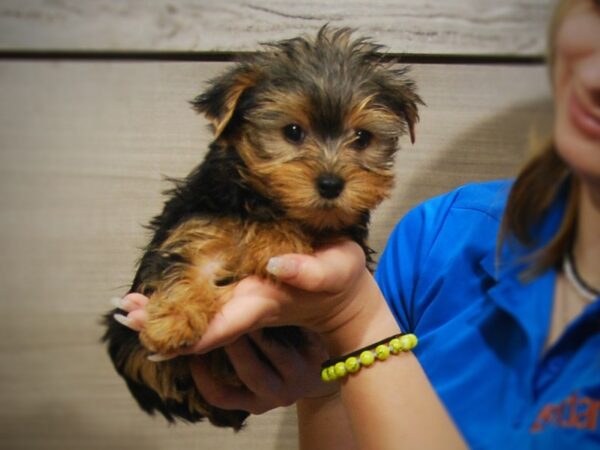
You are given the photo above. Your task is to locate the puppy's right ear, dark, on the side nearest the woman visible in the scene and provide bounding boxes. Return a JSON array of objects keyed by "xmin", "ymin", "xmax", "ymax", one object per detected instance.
[{"xmin": 377, "ymin": 69, "xmax": 425, "ymax": 144}]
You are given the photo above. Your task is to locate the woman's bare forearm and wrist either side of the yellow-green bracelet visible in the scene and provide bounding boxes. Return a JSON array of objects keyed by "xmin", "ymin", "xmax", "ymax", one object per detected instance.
[{"xmin": 325, "ymin": 272, "xmax": 466, "ymax": 450}]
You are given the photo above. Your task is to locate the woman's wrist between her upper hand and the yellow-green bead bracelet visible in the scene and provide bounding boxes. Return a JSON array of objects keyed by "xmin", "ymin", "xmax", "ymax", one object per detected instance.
[{"xmin": 322, "ymin": 270, "xmax": 401, "ymax": 357}]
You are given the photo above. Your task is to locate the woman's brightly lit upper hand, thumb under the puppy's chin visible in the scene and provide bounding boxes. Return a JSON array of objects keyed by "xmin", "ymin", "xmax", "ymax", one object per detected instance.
[{"xmin": 190, "ymin": 241, "xmax": 385, "ymax": 353}]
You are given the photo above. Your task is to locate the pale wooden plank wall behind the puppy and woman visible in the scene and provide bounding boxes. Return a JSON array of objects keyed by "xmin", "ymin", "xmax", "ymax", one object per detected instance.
[{"xmin": 0, "ymin": 0, "xmax": 553, "ymax": 450}]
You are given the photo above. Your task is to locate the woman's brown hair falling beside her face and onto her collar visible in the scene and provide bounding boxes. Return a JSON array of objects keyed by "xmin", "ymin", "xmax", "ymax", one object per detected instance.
[{"xmin": 498, "ymin": 0, "xmax": 579, "ymax": 279}]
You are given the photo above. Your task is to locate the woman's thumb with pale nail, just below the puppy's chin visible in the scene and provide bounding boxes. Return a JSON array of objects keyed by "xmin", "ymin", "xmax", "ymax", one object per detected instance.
[{"xmin": 267, "ymin": 241, "xmax": 365, "ymax": 294}]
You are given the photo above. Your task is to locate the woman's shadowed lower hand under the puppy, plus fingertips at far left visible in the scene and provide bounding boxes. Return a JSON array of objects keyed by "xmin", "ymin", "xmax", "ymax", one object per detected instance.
[{"xmin": 114, "ymin": 293, "xmax": 338, "ymax": 414}]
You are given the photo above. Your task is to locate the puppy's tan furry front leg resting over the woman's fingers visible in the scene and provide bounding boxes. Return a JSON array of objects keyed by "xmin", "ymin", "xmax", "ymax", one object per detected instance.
[{"xmin": 140, "ymin": 219, "xmax": 239, "ymax": 354}]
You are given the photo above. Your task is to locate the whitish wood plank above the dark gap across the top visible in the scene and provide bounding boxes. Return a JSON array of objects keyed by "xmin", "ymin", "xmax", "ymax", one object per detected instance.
[{"xmin": 0, "ymin": 0, "xmax": 556, "ymax": 56}]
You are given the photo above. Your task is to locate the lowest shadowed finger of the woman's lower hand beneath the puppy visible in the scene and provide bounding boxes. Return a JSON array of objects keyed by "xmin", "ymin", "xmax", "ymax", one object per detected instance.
[{"xmin": 190, "ymin": 357, "xmax": 256, "ymax": 412}]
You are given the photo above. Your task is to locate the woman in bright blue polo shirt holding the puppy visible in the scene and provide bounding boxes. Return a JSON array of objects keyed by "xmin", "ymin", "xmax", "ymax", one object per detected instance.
[{"xmin": 117, "ymin": 0, "xmax": 600, "ymax": 449}]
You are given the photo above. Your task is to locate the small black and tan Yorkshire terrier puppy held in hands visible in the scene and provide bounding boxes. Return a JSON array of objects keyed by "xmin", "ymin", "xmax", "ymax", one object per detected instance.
[{"xmin": 103, "ymin": 27, "xmax": 421, "ymax": 429}]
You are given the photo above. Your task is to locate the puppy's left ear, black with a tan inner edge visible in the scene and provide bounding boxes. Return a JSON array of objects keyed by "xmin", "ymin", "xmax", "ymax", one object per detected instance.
[{"xmin": 191, "ymin": 64, "xmax": 260, "ymax": 139}]
